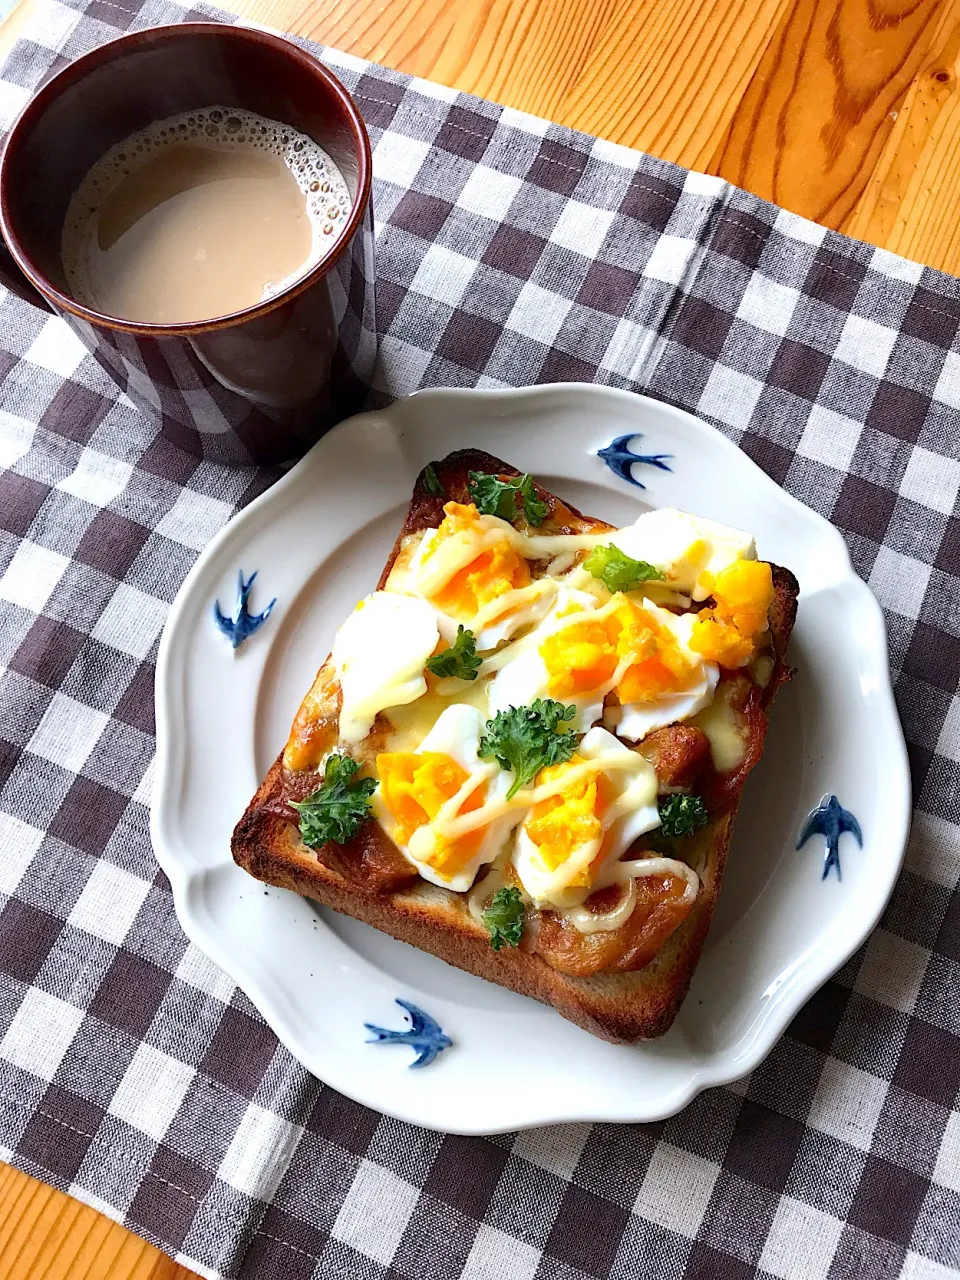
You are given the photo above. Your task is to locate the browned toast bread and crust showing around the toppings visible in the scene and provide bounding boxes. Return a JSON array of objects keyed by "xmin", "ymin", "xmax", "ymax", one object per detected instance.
[{"xmin": 232, "ymin": 449, "xmax": 797, "ymax": 1043}]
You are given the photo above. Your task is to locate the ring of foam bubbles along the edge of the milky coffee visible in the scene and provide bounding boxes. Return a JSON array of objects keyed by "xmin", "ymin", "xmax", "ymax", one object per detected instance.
[{"xmin": 61, "ymin": 106, "xmax": 352, "ymax": 306}]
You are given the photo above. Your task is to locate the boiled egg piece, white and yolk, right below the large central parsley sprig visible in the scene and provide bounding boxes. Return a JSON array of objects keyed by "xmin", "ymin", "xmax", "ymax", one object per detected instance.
[{"xmin": 512, "ymin": 727, "xmax": 660, "ymax": 910}]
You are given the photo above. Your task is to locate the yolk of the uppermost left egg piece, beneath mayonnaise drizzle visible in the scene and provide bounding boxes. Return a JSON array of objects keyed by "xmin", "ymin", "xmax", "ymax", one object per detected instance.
[{"xmin": 426, "ymin": 502, "xmax": 530, "ymax": 622}]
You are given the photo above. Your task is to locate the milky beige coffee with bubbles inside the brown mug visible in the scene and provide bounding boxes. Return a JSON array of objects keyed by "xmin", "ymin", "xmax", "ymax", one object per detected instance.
[{"xmin": 60, "ymin": 106, "xmax": 351, "ymax": 324}]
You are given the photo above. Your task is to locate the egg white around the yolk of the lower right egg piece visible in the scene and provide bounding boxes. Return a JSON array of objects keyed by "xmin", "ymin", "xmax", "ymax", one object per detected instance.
[{"xmin": 513, "ymin": 727, "xmax": 660, "ymax": 910}]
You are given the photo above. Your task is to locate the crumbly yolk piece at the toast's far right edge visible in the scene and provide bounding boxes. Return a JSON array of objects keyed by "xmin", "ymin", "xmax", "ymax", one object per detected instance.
[{"xmin": 690, "ymin": 561, "xmax": 774, "ymax": 668}]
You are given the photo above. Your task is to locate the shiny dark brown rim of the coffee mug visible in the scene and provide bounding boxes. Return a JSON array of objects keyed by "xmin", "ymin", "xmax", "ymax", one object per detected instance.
[{"xmin": 0, "ymin": 22, "xmax": 374, "ymax": 338}]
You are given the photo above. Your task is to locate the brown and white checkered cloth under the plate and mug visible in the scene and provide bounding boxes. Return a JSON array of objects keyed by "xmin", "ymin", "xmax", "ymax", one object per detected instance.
[{"xmin": 0, "ymin": 0, "xmax": 960, "ymax": 1280}]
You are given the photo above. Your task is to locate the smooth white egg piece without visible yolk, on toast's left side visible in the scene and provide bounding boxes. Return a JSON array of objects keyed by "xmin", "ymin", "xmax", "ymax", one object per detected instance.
[{"xmin": 332, "ymin": 591, "xmax": 439, "ymax": 744}]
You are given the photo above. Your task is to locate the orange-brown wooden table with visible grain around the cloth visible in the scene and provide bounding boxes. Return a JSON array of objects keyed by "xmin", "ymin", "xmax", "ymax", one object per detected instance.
[{"xmin": 0, "ymin": 0, "xmax": 960, "ymax": 1280}]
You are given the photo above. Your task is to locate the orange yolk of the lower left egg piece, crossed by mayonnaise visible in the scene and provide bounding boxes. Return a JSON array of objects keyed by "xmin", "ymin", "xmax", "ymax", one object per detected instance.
[{"xmin": 376, "ymin": 751, "xmax": 486, "ymax": 878}]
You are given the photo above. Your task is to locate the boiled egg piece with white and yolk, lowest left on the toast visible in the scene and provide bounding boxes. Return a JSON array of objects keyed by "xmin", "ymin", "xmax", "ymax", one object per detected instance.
[{"xmin": 371, "ymin": 703, "xmax": 522, "ymax": 893}]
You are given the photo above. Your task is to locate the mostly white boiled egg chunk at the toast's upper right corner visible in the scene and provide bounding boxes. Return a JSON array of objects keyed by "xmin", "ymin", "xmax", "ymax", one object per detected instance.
[{"xmin": 609, "ymin": 507, "xmax": 756, "ymax": 600}]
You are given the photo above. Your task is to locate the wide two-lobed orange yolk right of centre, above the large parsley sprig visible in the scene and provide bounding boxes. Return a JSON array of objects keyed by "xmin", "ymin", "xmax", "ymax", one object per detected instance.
[{"xmin": 540, "ymin": 595, "xmax": 696, "ymax": 703}]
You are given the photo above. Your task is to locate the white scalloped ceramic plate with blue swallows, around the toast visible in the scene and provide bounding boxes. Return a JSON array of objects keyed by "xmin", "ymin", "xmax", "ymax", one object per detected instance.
[{"xmin": 152, "ymin": 384, "xmax": 910, "ymax": 1133}]
